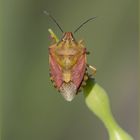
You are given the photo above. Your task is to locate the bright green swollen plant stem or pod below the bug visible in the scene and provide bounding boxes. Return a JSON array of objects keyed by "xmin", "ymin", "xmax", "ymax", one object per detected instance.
[{"xmin": 84, "ymin": 79, "xmax": 133, "ymax": 140}]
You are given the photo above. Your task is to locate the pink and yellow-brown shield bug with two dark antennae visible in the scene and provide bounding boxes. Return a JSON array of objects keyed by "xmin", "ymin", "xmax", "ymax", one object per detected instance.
[{"xmin": 44, "ymin": 11, "xmax": 96, "ymax": 101}]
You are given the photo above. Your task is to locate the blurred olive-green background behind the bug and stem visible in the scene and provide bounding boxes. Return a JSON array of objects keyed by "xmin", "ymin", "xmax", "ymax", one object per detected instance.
[{"xmin": 0, "ymin": 0, "xmax": 140, "ymax": 140}]
